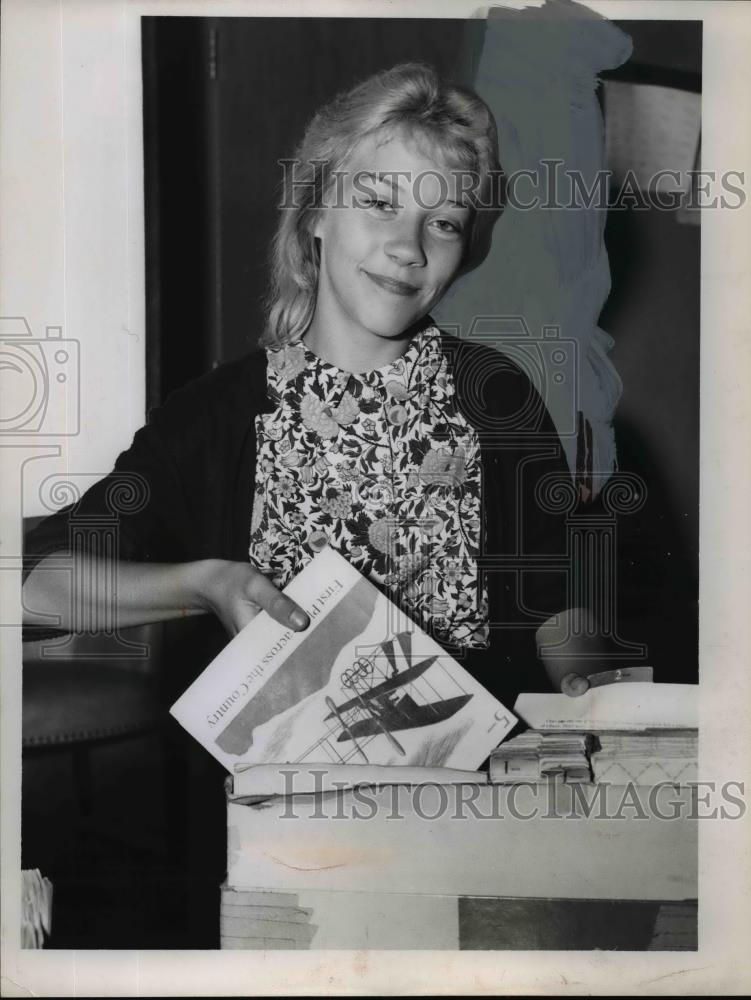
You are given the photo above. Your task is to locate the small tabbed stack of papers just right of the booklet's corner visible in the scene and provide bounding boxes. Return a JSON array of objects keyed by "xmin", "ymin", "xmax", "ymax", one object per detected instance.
[{"xmin": 490, "ymin": 731, "xmax": 592, "ymax": 784}]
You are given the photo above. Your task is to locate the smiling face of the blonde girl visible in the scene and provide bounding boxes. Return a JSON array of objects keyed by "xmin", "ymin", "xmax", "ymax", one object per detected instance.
[{"xmin": 312, "ymin": 136, "xmax": 470, "ymax": 360}]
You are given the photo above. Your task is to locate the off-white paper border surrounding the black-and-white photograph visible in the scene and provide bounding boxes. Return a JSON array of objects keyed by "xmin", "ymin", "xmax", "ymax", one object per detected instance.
[{"xmin": 0, "ymin": 0, "xmax": 751, "ymax": 996}]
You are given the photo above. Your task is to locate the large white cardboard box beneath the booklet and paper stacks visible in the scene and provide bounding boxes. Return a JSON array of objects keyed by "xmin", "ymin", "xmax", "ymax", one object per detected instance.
[{"xmin": 223, "ymin": 783, "xmax": 698, "ymax": 948}]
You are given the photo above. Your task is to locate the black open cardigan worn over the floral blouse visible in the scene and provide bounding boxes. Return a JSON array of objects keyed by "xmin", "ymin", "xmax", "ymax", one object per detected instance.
[{"xmin": 24, "ymin": 334, "xmax": 569, "ymax": 698}]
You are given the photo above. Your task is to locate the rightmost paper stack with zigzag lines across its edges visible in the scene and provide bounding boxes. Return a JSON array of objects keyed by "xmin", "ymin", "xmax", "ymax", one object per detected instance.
[{"xmin": 592, "ymin": 729, "xmax": 698, "ymax": 785}]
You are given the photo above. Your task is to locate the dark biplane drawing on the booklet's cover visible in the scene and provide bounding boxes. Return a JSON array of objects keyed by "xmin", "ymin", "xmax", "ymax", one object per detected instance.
[{"xmin": 296, "ymin": 631, "xmax": 472, "ymax": 763}]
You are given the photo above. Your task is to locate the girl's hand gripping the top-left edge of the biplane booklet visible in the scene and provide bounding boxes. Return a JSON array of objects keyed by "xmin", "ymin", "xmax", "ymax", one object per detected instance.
[{"xmin": 194, "ymin": 559, "xmax": 310, "ymax": 636}]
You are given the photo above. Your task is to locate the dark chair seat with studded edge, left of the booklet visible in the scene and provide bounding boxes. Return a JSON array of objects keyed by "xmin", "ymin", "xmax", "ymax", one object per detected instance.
[{"xmin": 23, "ymin": 660, "xmax": 163, "ymax": 748}]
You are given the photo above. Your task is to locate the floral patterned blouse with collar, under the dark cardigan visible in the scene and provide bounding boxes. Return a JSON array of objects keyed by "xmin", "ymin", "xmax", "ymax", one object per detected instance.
[{"xmin": 249, "ymin": 326, "xmax": 488, "ymax": 647}]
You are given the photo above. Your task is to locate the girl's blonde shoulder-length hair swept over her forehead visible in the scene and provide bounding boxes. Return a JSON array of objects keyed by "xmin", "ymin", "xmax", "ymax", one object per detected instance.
[{"xmin": 261, "ymin": 63, "xmax": 501, "ymax": 347}]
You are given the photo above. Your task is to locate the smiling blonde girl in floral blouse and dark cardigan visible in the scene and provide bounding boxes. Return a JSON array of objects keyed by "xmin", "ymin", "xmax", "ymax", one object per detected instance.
[{"xmin": 24, "ymin": 64, "xmax": 582, "ymax": 698}]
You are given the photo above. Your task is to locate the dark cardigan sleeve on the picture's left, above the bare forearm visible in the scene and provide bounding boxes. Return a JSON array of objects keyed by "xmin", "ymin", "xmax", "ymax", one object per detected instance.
[{"xmin": 23, "ymin": 351, "xmax": 267, "ymax": 639}]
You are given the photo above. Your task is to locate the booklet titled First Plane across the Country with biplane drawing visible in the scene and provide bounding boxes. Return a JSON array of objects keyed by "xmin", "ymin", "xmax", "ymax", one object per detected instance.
[{"xmin": 170, "ymin": 548, "xmax": 517, "ymax": 772}]
